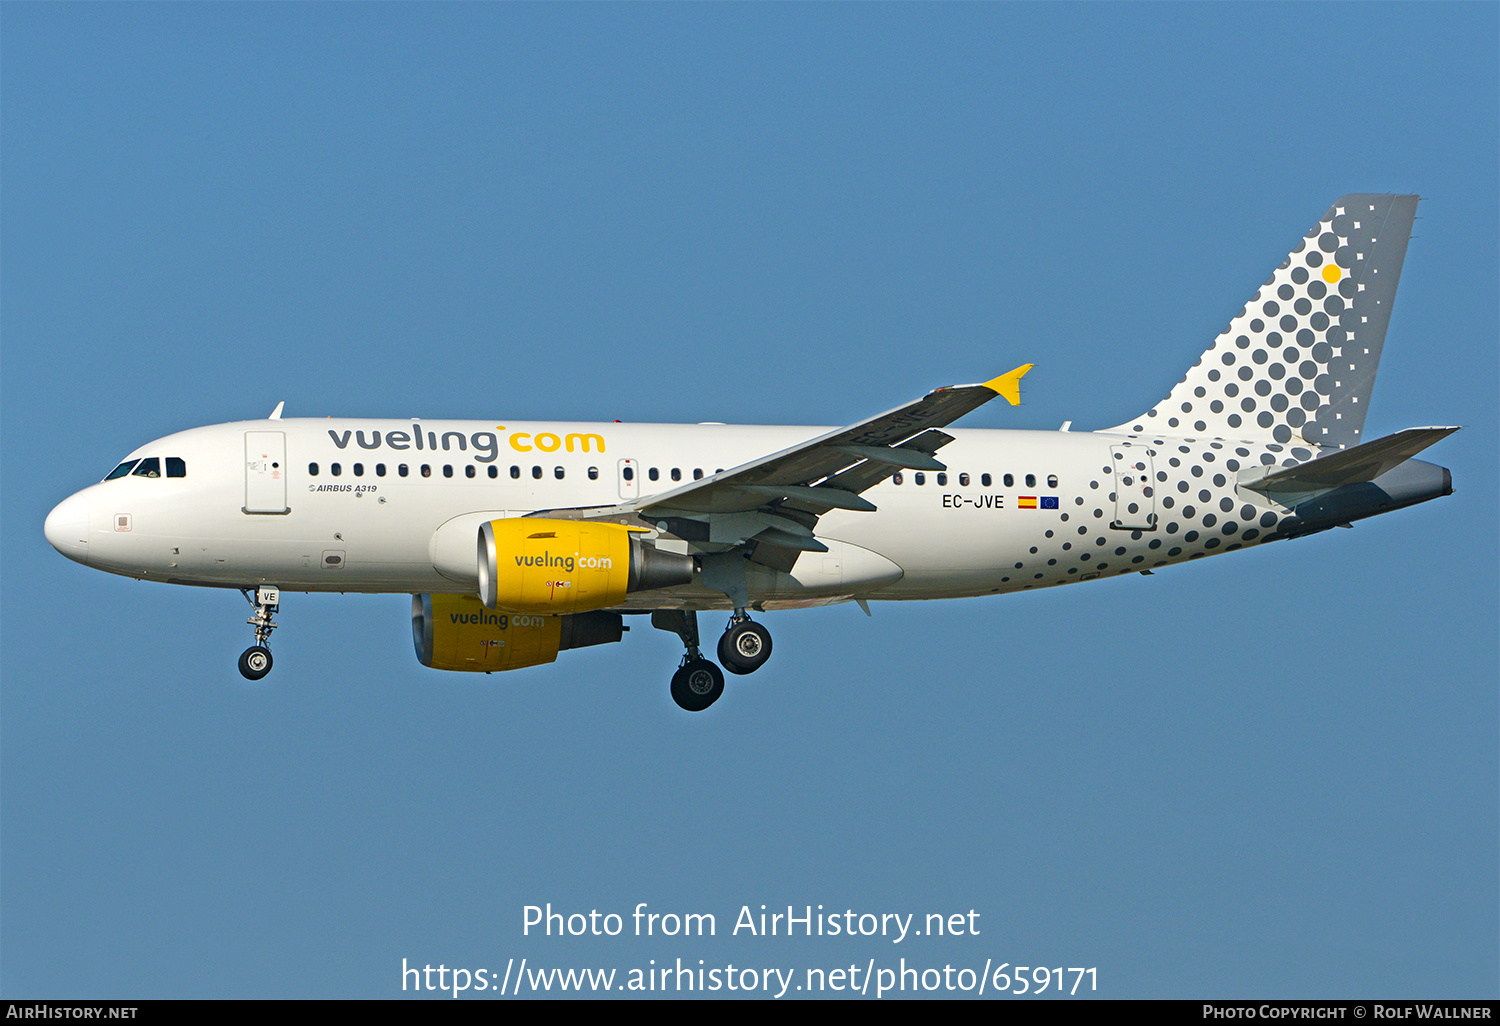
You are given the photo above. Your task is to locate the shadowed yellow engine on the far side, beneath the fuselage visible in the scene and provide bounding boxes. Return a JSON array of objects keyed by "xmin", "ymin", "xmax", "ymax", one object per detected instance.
[{"xmin": 411, "ymin": 596, "xmax": 626, "ymax": 674}]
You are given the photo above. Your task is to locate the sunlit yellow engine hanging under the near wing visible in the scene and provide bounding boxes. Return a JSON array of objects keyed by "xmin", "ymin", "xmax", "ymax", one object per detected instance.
[{"xmin": 479, "ymin": 516, "xmax": 693, "ymax": 615}]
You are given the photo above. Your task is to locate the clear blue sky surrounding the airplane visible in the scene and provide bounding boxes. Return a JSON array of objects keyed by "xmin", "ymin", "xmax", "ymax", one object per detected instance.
[{"xmin": 0, "ymin": 5, "xmax": 1500, "ymax": 998}]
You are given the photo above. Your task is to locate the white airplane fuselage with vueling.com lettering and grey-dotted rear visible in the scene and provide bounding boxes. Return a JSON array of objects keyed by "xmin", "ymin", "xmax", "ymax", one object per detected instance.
[{"xmin": 48, "ymin": 419, "xmax": 1314, "ymax": 609}]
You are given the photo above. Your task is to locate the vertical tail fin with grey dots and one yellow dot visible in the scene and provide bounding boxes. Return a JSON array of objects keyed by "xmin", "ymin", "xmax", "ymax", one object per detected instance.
[{"xmin": 1110, "ymin": 194, "xmax": 1418, "ymax": 449}]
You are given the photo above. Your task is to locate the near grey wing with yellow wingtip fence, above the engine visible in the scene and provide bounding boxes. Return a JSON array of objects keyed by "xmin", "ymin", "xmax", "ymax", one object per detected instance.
[{"xmin": 534, "ymin": 363, "xmax": 1032, "ymax": 569}]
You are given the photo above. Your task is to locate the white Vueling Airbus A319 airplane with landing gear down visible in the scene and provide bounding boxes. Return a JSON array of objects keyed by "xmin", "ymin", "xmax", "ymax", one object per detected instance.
[{"xmin": 44, "ymin": 194, "xmax": 1458, "ymax": 711}]
